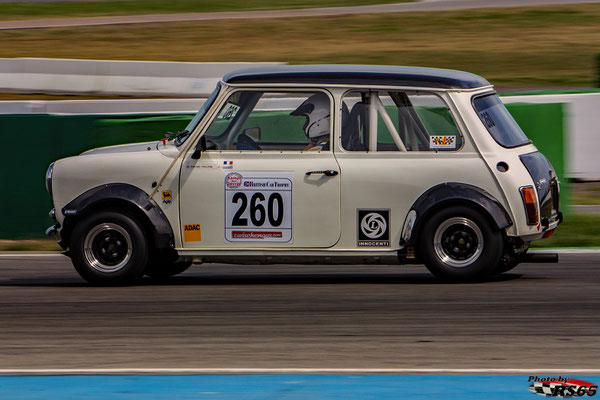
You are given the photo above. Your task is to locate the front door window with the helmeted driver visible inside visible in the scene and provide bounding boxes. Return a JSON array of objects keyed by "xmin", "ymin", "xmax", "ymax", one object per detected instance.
[{"xmin": 205, "ymin": 91, "xmax": 331, "ymax": 151}]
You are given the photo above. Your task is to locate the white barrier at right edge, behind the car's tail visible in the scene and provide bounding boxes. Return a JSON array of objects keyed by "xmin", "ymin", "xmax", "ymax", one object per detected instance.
[{"xmin": 502, "ymin": 93, "xmax": 600, "ymax": 180}]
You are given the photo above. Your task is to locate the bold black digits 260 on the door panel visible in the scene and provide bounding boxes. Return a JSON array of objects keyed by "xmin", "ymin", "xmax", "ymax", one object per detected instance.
[{"xmin": 231, "ymin": 192, "xmax": 283, "ymax": 227}]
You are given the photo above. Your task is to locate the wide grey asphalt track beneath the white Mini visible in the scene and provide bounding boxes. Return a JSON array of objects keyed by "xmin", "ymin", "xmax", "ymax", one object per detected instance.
[{"xmin": 0, "ymin": 253, "xmax": 600, "ymax": 370}]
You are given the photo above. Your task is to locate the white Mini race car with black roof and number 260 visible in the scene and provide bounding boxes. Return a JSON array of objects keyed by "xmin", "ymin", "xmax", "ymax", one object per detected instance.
[{"xmin": 46, "ymin": 65, "xmax": 562, "ymax": 284}]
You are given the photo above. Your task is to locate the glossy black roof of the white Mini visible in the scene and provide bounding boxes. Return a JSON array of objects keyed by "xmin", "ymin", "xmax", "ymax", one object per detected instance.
[{"xmin": 223, "ymin": 65, "xmax": 490, "ymax": 89}]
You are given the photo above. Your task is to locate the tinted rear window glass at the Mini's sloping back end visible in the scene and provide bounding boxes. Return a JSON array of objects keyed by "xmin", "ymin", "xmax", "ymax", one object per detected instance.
[{"xmin": 473, "ymin": 94, "xmax": 531, "ymax": 147}]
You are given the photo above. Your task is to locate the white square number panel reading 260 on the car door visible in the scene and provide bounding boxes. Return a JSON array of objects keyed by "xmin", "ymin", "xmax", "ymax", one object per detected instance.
[{"xmin": 224, "ymin": 172, "xmax": 294, "ymax": 243}]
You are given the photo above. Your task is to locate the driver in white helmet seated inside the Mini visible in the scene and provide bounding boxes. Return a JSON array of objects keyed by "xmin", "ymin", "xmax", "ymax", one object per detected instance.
[{"xmin": 290, "ymin": 93, "xmax": 330, "ymax": 151}]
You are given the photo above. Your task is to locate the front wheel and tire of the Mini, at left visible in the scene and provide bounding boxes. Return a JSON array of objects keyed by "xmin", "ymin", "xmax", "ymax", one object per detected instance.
[{"xmin": 70, "ymin": 211, "xmax": 149, "ymax": 286}]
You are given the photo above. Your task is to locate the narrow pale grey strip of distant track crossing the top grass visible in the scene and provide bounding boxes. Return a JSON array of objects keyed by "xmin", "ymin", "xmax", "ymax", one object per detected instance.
[{"xmin": 0, "ymin": 0, "xmax": 600, "ymax": 30}]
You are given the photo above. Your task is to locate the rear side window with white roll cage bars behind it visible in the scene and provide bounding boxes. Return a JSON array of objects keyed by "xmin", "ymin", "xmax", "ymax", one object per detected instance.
[{"xmin": 342, "ymin": 91, "xmax": 462, "ymax": 151}]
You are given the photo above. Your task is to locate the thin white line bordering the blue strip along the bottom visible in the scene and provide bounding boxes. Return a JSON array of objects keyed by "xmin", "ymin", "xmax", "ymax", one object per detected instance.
[{"xmin": 0, "ymin": 368, "xmax": 600, "ymax": 375}]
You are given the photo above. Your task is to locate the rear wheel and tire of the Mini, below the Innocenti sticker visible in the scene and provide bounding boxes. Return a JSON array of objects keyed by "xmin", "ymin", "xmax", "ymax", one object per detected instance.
[{"xmin": 418, "ymin": 206, "xmax": 504, "ymax": 280}]
